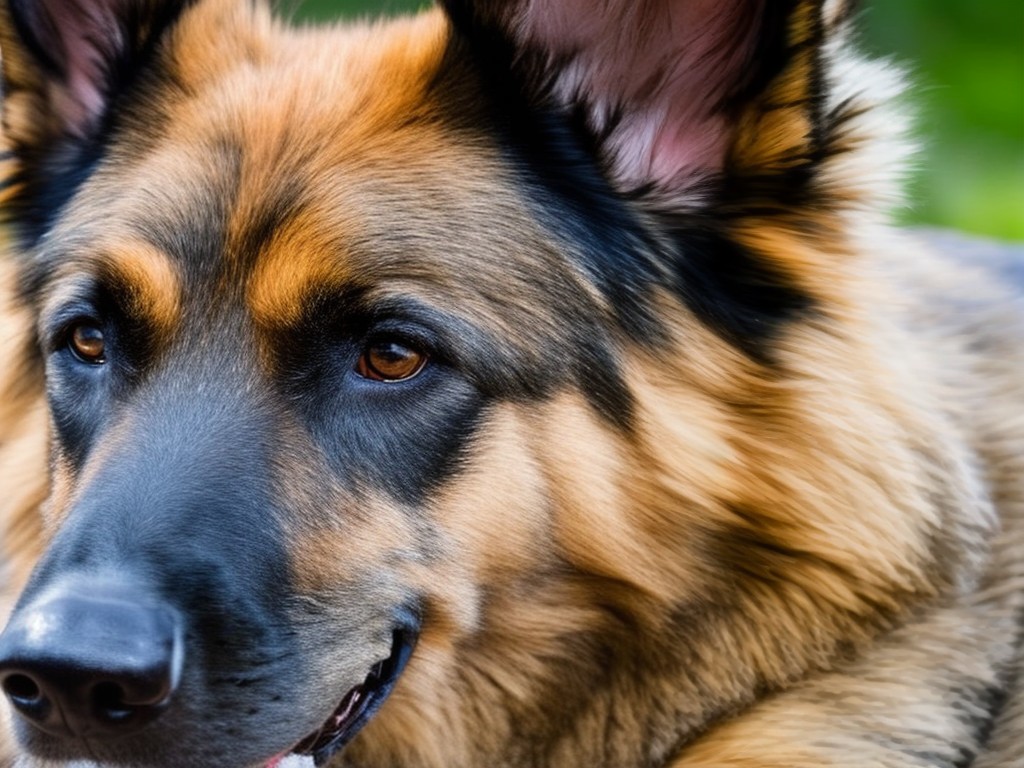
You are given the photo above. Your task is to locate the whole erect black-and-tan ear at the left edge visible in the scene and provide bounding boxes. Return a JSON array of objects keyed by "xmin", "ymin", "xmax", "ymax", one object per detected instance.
[{"xmin": 0, "ymin": 0, "xmax": 190, "ymax": 240}]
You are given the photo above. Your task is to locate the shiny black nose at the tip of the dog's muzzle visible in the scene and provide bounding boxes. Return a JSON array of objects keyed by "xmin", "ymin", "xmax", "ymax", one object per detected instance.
[{"xmin": 0, "ymin": 585, "xmax": 183, "ymax": 737}]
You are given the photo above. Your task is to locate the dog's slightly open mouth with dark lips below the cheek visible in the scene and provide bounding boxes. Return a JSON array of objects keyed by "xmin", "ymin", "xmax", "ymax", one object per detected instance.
[{"xmin": 266, "ymin": 629, "xmax": 418, "ymax": 768}]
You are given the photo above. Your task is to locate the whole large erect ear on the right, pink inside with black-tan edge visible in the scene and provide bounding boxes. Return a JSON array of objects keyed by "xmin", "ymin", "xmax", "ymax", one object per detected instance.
[{"xmin": 444, "ymin": 0, "xmax": 851, "ymax": 197}]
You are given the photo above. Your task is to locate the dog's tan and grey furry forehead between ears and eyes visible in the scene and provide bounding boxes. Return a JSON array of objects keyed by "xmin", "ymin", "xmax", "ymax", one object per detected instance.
[{"xmin": 49, "ymin": 7, "xmax": 579, "ymax": 335}]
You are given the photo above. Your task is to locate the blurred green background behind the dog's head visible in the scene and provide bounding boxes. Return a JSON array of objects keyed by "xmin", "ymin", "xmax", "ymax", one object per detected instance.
[{"xmin": 286, "ymin": 0, "xmax": 1024, "ymax": 240}]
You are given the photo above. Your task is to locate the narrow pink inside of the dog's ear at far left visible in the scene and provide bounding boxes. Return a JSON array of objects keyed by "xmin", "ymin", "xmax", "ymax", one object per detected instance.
[{"xmin": 40, "ymin": 0, "xmax": 126, "ymax": 136}]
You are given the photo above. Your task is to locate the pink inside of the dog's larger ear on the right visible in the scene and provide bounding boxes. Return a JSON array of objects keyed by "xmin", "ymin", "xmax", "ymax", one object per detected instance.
[{"xmin": 515, "ymin": 0, "xmax": 765, "ymax": 188}]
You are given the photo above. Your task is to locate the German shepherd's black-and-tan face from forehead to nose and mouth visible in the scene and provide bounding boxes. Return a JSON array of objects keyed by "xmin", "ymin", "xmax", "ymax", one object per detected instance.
[{"xmin": 5, "ymin": 3, "xmax": 655, "ymax": 766}]
